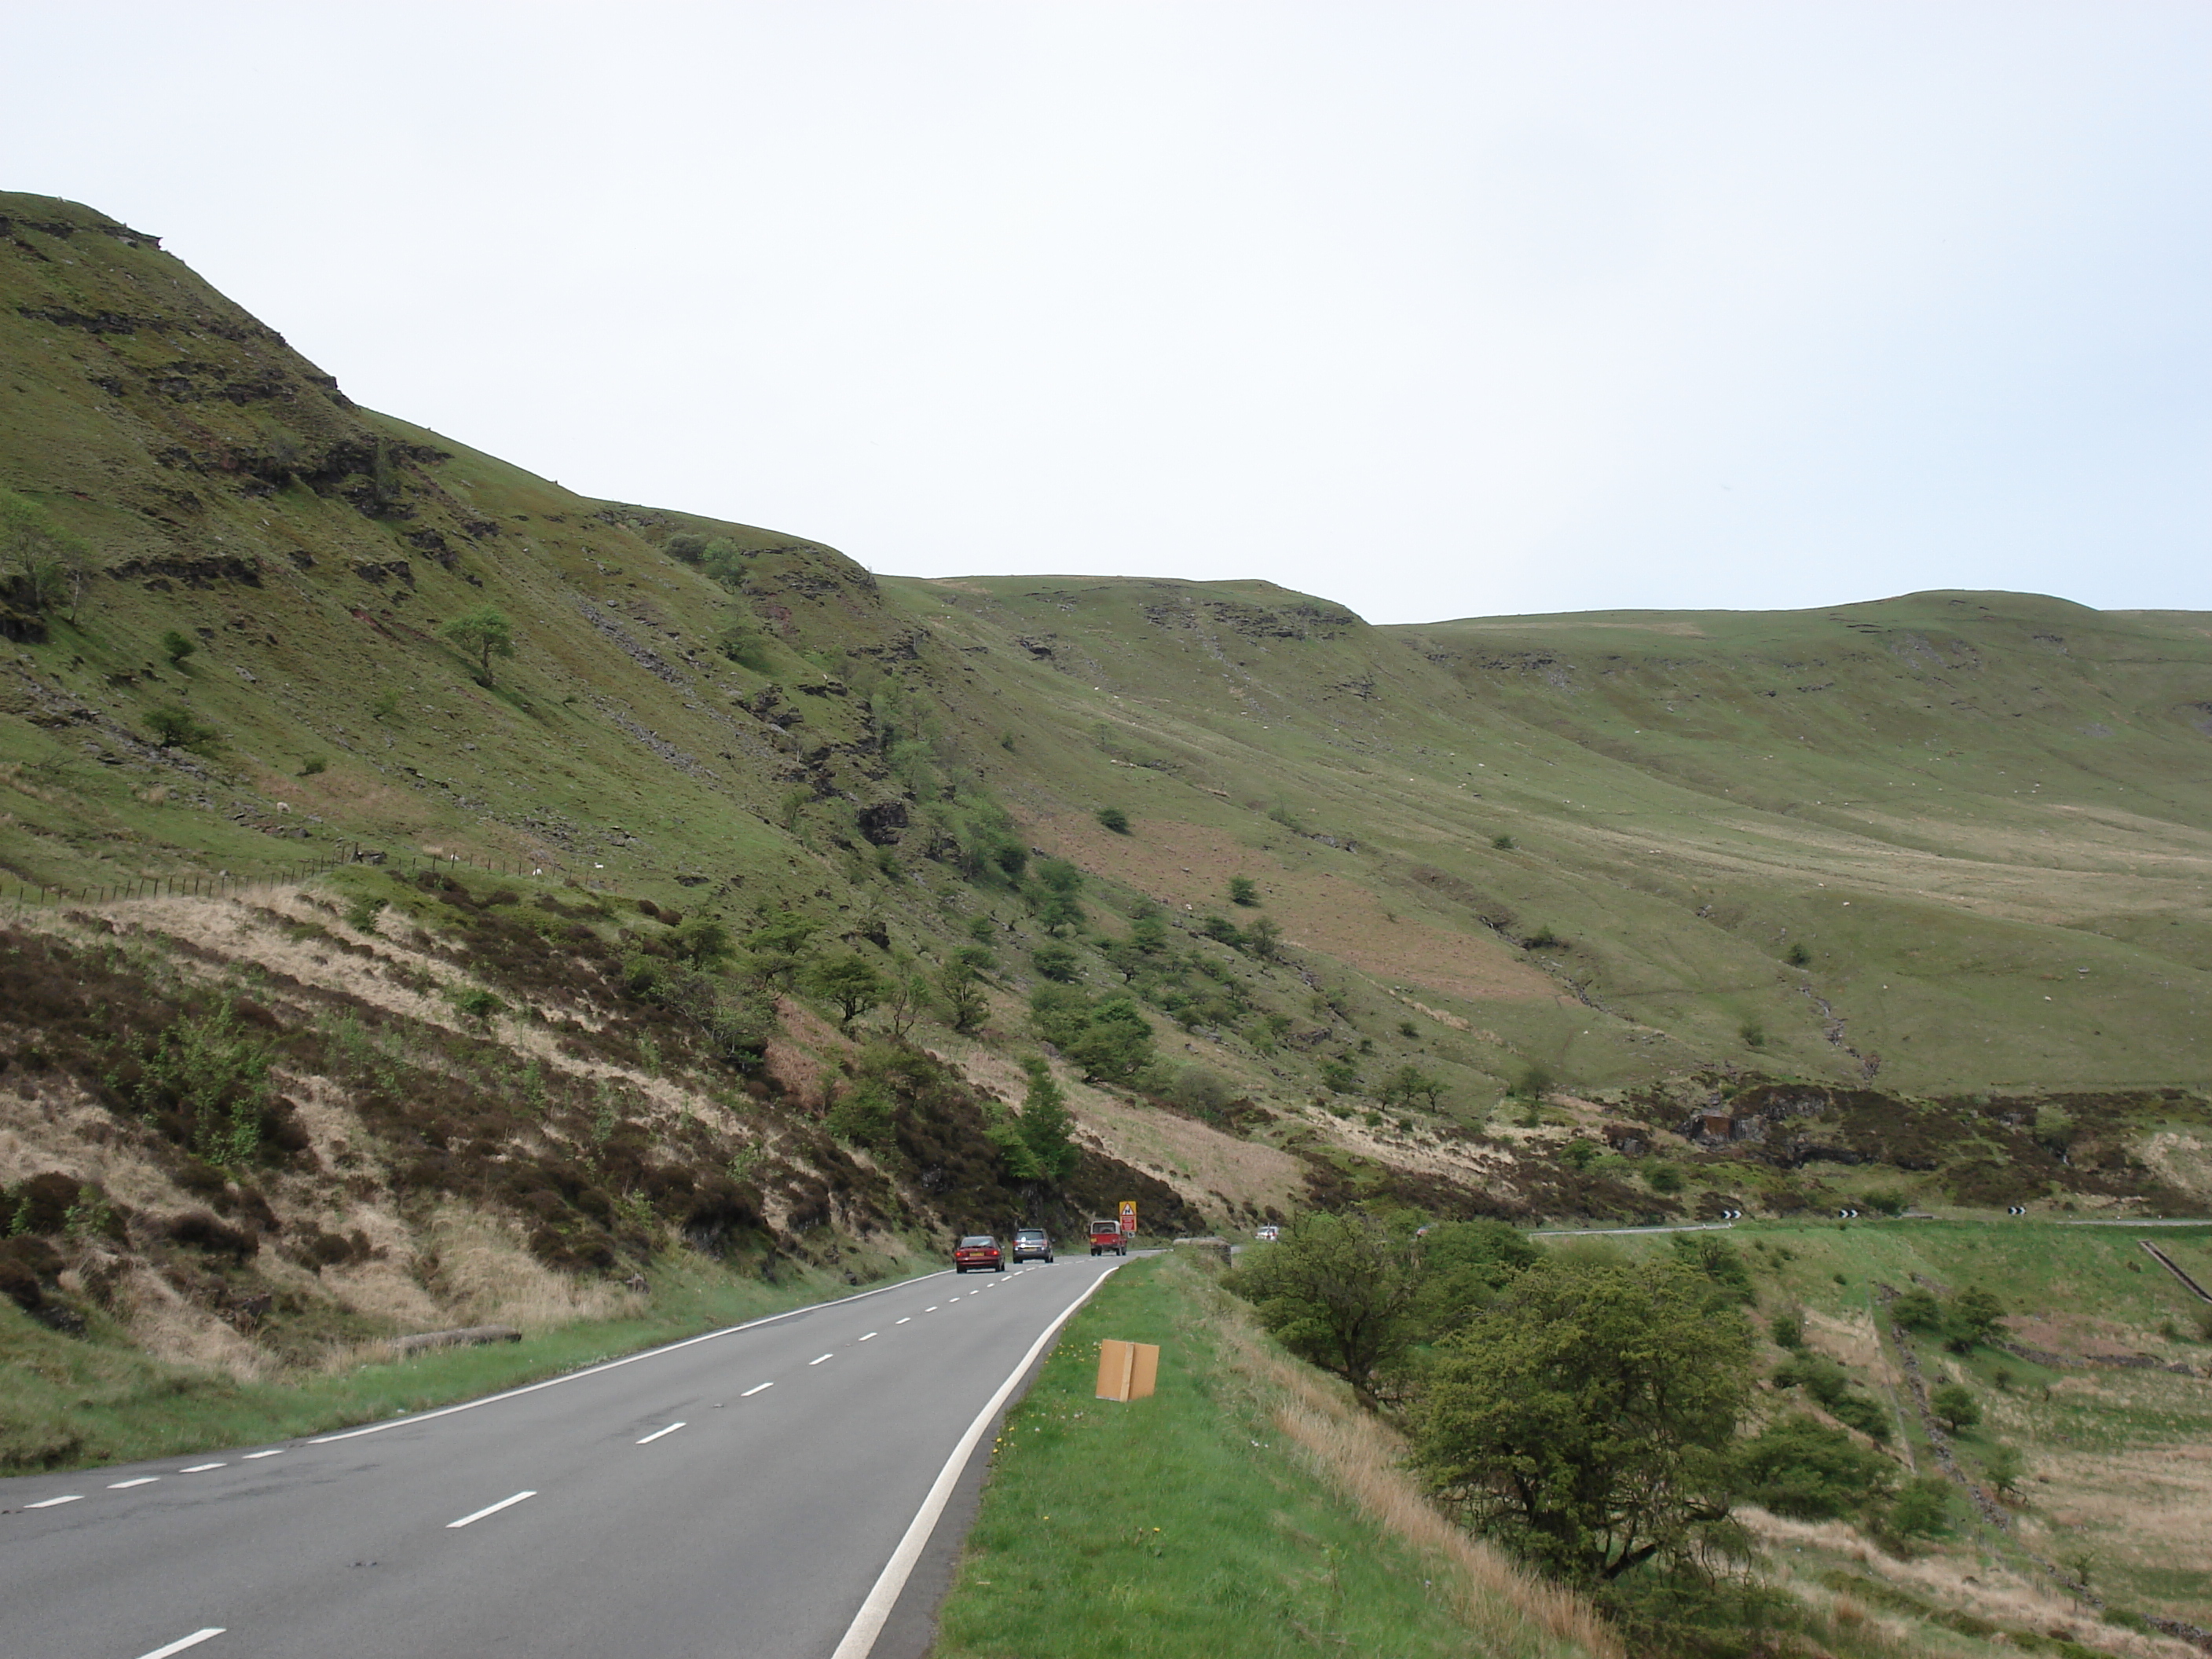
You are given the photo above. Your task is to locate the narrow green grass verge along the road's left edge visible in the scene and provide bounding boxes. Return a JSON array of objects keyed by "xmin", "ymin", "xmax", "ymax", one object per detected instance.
[{"xmin": 0, "ymin": 1261, "xmax": 936, "ymax": 1475}]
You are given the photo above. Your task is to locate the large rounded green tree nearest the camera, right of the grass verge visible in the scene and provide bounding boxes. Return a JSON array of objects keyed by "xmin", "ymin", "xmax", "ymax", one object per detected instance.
[{"xmin": 1409, "ymin": 1256, "xmax": 1752, "ymax": 1584}]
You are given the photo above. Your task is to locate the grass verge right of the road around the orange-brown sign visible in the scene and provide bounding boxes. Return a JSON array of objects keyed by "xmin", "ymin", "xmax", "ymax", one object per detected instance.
[{"xmin": 936, "ymin": 1256, "xmax": 1619, "ymax": 1659}]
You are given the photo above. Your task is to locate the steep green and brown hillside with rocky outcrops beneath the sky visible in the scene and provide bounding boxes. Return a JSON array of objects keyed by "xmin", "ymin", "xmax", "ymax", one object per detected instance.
[{"xmin": 0, "ymin": 197, "xmax": 2212, "ymax": 1415}]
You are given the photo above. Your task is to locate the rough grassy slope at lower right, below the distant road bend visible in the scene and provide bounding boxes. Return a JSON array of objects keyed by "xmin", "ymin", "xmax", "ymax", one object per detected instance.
[{"xmin": 1619, "ymin": 1219, "xmax": 2212, "ymax": 1641}]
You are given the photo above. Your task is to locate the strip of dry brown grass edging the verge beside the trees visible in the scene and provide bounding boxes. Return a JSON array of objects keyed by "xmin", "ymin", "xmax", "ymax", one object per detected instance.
[{"xmin": 1214, "ymin": 1292, "xmax": 1626, "ymax": 1659}]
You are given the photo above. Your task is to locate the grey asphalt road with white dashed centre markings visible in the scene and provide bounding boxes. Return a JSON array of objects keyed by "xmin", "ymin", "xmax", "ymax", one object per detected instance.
[{"xmin": 0, "ymin": 1256, "xmax": 1119, "ymax": 1659}]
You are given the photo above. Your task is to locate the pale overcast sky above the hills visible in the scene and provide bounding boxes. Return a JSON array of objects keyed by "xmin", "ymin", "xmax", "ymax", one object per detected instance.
[{"xmin": 0, "ymin": 0, "xmax": 2212, "ymax": 621}]
